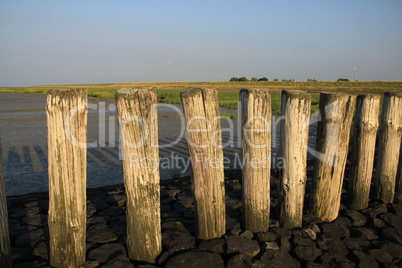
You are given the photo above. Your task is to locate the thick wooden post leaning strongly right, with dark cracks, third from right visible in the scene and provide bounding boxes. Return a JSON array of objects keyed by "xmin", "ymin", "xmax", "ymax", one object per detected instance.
[{"xmin": 312, "ymin": 93, "xmax": 356, "ymax": 222}]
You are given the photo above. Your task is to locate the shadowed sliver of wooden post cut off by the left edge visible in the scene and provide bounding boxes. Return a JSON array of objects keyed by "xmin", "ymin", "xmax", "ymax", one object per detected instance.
[{"xmin": 0, "ymin": 142, "xmax": 12, "ymax": 268}]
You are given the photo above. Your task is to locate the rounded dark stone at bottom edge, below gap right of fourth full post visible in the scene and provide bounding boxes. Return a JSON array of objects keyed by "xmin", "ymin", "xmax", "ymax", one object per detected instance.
[{"xmin": 260, "ymin": 250, "xmax": 301, "ymax": 268}]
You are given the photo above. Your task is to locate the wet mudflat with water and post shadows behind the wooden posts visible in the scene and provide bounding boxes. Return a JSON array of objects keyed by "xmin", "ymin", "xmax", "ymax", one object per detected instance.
[{"xmin": 0, "ymin": 93, "xmax": 240, "ymax": 195}]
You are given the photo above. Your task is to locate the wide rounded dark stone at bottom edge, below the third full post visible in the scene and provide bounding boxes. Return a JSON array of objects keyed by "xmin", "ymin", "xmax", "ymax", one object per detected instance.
[{"xmin": 165, "ymin": 251, "xmax": 225, "ymax": 268}]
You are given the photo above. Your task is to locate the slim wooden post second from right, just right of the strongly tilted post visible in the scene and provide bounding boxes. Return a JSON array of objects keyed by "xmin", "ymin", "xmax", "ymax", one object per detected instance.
[{"xmin": 348, "ymin": 95, "xmax": 380, "ymax": 210}]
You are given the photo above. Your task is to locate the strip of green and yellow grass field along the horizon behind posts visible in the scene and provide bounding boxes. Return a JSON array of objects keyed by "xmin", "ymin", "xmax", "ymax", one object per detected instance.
[{"xmin": 0, "ymin": 81, "xmax": 402, "ymax": 114}]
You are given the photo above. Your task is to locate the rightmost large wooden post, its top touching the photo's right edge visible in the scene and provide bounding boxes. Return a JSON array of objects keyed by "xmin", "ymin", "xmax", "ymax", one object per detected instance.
[{"xmin": 374, "ymin": 93, "xmax": 402, "ymax": 203}]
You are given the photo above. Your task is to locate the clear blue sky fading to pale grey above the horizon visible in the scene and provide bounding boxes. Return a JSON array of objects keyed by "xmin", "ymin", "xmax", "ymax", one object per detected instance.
[{"xmin": 0, "ymin": 0, "xmax": 402, "ymax": 86}]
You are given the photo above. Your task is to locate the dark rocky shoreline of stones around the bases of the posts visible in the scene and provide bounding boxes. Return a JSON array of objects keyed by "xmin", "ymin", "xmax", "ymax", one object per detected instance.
[{"xmin": 7, "ymin": 170, "xmax": 402, "ymax": 268}]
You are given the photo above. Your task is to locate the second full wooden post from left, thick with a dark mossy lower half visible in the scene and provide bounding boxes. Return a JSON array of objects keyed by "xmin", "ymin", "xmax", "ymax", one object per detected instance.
[{"xmin": 116, "ymin": 88, "xmax": 162, "ymax": 263}]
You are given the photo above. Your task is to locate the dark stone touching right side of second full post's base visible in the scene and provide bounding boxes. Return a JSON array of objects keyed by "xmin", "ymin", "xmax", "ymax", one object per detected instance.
[{"xmin": 162, "ymin": 229, "xmax": 196, "ymax": 254}]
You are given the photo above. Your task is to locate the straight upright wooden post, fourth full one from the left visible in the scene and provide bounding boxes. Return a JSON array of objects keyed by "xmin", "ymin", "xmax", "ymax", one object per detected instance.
[{"xmin": 240, "ymin": 89, "xmax": 271, "ymax": 233}]
